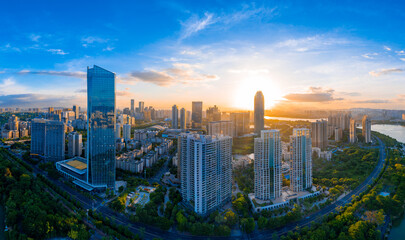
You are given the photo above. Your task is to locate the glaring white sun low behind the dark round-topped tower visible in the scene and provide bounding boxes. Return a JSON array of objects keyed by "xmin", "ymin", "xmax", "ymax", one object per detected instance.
[{"xmin": 233, "ymin": 76, "xmax": 283, "ymax": 110}]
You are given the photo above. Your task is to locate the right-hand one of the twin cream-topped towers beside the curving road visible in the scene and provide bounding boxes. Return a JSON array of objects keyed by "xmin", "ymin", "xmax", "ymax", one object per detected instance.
[{"xmin": 290, "ymin": 128, "xmax": 312, "ymax": 192}]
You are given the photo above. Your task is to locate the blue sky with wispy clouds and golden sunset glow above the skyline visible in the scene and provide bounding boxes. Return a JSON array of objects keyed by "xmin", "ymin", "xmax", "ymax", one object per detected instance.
[{"xmin": 0, "ymin": 0, "xmax": 405, "ymax": 110}]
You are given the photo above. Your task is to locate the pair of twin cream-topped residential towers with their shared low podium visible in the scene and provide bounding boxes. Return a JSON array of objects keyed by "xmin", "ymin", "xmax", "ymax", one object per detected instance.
[{"xmin": 249, "ymin": 128, "xmax": 312, "ymax": 209}]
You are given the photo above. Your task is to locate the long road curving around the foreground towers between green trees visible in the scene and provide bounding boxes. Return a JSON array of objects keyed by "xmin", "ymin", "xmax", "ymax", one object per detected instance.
[{"xmin": 6, "ymin": 138, "xmax": 386, "ymax": 240}]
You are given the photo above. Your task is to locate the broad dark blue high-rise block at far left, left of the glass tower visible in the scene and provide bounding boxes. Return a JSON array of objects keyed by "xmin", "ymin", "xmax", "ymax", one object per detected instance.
[{"xmin": 31, "ymin": 119, "xmax": 65, "ymax": 161}]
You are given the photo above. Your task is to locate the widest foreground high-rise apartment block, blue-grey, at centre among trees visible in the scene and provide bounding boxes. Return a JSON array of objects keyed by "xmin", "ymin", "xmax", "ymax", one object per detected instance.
[{"xmin": 178, "ymin": 133, "xmax": 232, "ymax": 215}]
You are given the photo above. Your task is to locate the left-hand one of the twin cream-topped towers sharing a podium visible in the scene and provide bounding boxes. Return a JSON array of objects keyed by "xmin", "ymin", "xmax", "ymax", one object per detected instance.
[{"xmin": 254, "ymin": 130, "xmax": 282, "ymax": 200}]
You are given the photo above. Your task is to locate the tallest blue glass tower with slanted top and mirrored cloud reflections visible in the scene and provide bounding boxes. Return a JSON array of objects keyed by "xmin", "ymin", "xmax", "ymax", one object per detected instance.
[{"xmin": 87, "ymin": 65, "xmax": 116, "ymax": 188}]
